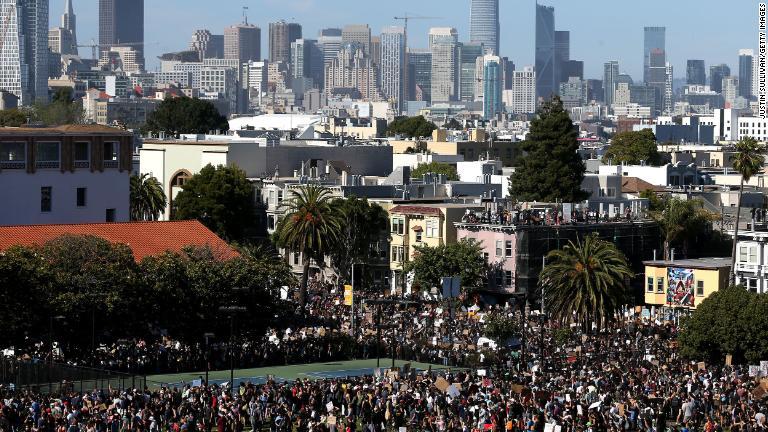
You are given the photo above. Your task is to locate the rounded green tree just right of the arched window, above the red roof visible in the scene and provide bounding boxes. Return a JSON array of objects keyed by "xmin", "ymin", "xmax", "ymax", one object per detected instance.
[{"xmin": 171, "ymin": 164, "xmax": 254, "ymax": 241}]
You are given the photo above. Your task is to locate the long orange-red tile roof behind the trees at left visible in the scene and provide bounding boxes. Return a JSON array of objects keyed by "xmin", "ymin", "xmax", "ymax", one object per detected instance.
[{"xmin": 0, "ymin": 221, "xmax": 239, "ymax": 262}]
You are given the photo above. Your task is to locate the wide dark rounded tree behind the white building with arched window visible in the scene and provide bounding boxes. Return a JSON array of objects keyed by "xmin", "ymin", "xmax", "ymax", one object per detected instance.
[{"xmin": 144, "ymin": 97, "xmax": 229, "ymax": 136}]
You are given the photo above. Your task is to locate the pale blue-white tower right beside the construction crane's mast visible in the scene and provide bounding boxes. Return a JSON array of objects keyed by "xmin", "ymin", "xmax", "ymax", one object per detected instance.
[{"xmin": 377, "ymin": 27, "xmax": 406, "ymax": 113}]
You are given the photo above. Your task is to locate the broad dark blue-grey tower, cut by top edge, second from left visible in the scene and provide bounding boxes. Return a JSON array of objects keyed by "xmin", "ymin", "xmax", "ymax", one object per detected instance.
[{"xmin": 99, "ymin": 0, "xmax": 144, "ymax": 66}]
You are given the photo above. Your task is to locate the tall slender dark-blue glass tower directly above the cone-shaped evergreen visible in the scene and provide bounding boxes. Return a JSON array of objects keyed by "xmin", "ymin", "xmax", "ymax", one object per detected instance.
[{"xmin": 536, "ymin": 4, "xmax": 557, "ymax": 99}]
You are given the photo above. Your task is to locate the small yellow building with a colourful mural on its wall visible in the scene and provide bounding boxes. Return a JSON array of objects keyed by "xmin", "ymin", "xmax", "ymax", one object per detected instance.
[{"xmin": 643, "ymin": 258, "xmax": 731, "ymax": 309}]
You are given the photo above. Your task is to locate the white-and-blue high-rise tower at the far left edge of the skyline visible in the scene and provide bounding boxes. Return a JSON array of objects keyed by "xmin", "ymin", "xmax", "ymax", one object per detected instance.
[{"xmin": 0, "ymin": 0, "xmax": 49, "ymax": 105}]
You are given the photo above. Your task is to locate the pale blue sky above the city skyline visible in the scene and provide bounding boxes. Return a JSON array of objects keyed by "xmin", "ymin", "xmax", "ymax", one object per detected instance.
[{"xmin": 50, "ymin": 0, "xmax": 758, "ymax": 79}]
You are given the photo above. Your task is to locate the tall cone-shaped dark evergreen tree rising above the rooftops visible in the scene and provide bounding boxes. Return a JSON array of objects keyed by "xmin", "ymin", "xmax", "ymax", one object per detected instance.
[{"xmin": 509, "ymin": 96, "xmax": 588, "ymax": 202}]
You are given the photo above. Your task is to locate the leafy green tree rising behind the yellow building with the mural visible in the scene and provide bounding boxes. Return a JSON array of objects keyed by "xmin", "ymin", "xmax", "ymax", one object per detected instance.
[{"xmin": 650, "ymin": 198, "xmax": 718, "ymax": 259}]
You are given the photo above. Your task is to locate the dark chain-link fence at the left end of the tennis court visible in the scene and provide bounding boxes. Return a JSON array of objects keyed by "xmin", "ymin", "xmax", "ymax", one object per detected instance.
[{"xmin": 0, "ymin": 357, "xmax": 147, "ymax": 393}]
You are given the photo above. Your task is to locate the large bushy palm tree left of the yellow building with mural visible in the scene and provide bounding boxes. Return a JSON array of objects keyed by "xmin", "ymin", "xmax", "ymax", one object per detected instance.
[{"xmin": 539, "ymin": 234, "xmax": 632, "ymax": 332}]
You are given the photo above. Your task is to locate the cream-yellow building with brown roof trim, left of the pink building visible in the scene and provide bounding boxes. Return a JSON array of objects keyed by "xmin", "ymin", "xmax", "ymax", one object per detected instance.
[{"xmin": 387, "ymin": 203, "xmax": 482, "ymax": 290}]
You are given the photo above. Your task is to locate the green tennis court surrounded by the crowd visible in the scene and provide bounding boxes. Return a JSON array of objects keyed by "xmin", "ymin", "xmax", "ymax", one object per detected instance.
[{"xmin": 147, "ymin": 359, "xmax": 445, "ymax": 387}]
